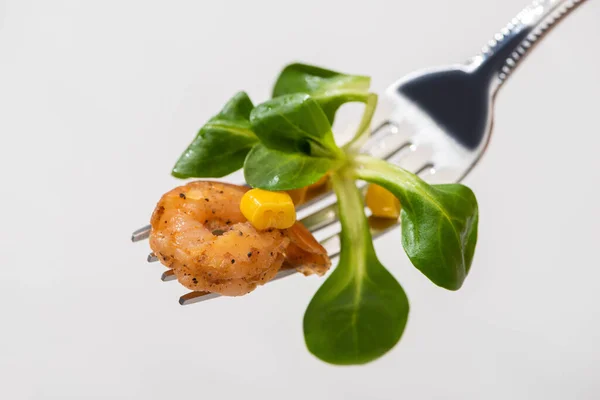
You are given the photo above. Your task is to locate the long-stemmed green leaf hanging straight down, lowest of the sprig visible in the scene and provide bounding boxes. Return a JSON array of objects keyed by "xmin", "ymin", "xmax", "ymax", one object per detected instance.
[{"xmin": 304, "ymin": 170, "xmax": 409, "ymax": 365}]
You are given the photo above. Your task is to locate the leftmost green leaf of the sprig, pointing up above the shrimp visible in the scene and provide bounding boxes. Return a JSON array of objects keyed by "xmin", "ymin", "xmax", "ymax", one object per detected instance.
[{"xmin": 172, "ymin": 92, "xmax": 258, "ymax": 178}]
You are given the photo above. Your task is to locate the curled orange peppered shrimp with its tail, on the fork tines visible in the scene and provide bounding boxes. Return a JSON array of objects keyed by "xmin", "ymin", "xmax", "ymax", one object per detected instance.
[{"xmin": 150, "ymin": 181, "xmax": 329, "ymax": 296}]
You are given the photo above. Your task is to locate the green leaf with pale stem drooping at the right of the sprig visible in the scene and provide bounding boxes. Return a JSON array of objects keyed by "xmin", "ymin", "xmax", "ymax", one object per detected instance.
[{"xmin": 356, "ymin": 156, "xmax": 479, "ymax": 290}]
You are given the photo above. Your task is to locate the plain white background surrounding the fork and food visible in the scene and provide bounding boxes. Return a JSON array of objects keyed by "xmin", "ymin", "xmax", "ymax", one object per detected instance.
[{"xmin": 0, "ymin": 0, "xmax": 600, "ymax": 400}]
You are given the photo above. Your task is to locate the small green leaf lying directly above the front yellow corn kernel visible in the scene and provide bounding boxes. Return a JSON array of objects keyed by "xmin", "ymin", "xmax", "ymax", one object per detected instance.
[{"xmin": 244, "ymin": 144, "xmax": 339, "ymax": 190}]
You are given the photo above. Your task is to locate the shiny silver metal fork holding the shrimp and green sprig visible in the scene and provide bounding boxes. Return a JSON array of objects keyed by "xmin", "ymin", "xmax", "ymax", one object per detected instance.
[{"xmin": 131, "ymin": 0, "xmax": 586, "ymax": 305}]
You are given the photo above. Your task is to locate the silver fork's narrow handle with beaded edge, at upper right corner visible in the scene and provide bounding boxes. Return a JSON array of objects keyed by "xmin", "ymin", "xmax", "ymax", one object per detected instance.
[{"xmin": 473, "ymin": 0, "xmax": 586, "ymax": 92}]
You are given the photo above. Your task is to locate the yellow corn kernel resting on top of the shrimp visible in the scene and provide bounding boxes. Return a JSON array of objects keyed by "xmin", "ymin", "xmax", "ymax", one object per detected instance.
[{"xmin": 240, "ymin": 189, "xmax": 296, "ymax": 230}]
